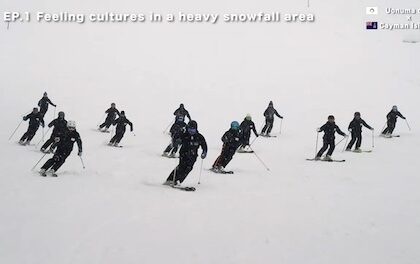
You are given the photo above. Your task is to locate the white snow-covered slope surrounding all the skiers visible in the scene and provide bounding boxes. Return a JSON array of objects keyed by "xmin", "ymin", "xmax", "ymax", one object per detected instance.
[{"xmin": 0, "ymin": 0, "xmax": 420, "ymax": 264}]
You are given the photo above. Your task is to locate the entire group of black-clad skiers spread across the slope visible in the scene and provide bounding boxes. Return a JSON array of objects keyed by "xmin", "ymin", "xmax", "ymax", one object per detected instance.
[{"xmin": 14, "ymin": 93, "xmax": 405, "ymax": 182}]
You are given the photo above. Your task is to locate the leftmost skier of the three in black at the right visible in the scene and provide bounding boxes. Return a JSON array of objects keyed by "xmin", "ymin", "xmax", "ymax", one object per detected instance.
[{"xmin": 315, "ymin": 115, "xmax": 348, "ymax": 161}]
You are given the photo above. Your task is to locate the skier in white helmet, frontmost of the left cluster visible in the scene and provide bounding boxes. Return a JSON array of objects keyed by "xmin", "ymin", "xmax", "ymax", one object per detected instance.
[{"xmin": 39, "ymin": 121, "xmax": 82, "ymax": 177}]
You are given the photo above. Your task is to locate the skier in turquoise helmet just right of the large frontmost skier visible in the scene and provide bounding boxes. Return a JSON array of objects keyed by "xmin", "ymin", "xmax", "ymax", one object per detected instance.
[{"xmin": 213, "ymin": 121, "xmax": 242, "ymax": 172}]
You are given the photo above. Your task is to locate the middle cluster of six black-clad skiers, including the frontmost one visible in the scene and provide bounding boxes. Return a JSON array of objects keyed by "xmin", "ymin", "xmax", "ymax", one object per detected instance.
[{"xmin": 162, "ymin": 101, "xmax": 283, "ymax": 186}]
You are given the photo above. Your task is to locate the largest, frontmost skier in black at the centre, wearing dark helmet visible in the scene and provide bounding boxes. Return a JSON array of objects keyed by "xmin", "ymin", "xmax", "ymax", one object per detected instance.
[{"xmin": 164, "ymin": 120, "xmax": 207, "ymax": 185}]
